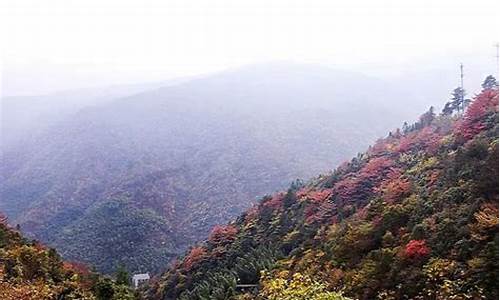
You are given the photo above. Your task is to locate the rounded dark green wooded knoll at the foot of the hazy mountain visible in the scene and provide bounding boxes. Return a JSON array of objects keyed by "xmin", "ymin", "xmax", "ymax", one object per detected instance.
[{"xmin": 52, "ymin": 199, "xmax": 177, "ymax": 274}]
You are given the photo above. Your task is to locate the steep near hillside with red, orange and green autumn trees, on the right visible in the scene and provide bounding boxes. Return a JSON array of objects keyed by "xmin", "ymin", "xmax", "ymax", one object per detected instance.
[{"xmin": 146, "ymin": 83, "xmax": 499, "ymax": 300}]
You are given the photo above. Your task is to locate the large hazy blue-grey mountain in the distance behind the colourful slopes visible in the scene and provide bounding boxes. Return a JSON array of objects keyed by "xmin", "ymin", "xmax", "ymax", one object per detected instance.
[{"xmin": 0, "ymin": 64, "xmax": 442, "ymax": 273}]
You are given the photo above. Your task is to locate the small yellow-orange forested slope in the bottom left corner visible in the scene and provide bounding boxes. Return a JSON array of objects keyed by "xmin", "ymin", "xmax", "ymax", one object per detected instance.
[{"xmin": 0, "ymin": 213, "xmax": 137, "ymax": 300}]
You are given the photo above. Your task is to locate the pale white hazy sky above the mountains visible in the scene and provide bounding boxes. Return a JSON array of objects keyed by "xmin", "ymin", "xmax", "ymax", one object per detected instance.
[{"xmin": 0, "ymin": 0, "xmax": 500, "ymax": 95}]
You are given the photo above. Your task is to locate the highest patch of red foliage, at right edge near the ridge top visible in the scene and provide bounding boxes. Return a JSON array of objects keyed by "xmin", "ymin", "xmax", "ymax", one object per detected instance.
[{"xmin": 455, "ymin": 89, "xmax": 498, "ymax": 139}]
